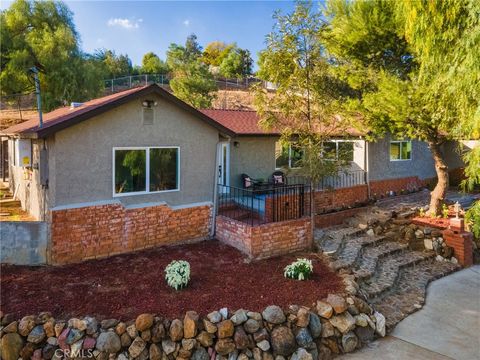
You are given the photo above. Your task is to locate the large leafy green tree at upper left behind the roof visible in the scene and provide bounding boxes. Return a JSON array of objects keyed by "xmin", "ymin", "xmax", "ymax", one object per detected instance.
[{"xmin": 0, "ymin": 0, "xmax": 102, "ymax": 110}]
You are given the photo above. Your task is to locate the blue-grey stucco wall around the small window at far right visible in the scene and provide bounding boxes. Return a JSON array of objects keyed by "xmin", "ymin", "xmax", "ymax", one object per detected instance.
[{"xmin": 368, "ymin": 136, "xmax": 436, "ymax": 180}]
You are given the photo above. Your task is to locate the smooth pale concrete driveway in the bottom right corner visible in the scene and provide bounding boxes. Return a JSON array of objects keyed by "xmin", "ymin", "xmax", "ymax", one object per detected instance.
[{"xmin": 339, "ymin": 265, "xmax": 480, "ymax": 360}]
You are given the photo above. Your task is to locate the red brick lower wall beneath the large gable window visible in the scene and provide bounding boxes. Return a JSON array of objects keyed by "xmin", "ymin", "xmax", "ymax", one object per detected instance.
[{"xmin": 49, "ymin": 203, "xmax": 212, "ymax": 264}]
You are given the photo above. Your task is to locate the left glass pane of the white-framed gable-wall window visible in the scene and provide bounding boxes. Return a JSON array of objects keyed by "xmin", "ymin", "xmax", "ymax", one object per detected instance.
[{"xmin": 115, "ymin": 150, "xmax": 147, "ymax": 194}]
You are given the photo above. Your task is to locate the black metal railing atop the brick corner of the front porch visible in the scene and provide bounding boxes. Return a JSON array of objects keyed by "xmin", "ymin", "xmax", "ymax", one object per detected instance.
[{"xmin": 217, "ymin": 184, "xmax": 310, "ymax": 226}]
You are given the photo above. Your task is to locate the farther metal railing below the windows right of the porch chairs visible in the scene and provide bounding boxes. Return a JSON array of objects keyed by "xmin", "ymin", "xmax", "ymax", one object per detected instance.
[{"xmin": 287, "ymin": 170, "xmax": 367, "ymax": 190}]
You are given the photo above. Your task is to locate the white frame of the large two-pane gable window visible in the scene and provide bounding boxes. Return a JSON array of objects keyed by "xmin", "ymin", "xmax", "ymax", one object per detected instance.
[{"xmin": 112, "ymin": 146, "xmax": 181, "ymax": 198}]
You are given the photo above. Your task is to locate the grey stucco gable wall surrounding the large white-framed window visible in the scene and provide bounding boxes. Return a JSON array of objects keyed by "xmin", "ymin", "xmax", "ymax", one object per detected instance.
[{"xmin": 49, "ymin": 95, "xmax": 218, "ymax": 206}]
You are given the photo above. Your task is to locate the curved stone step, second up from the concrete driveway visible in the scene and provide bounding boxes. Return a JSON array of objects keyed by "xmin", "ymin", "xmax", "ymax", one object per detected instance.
[{"xmin": 360, "ymin": 251, "xmax": 435, "ymax": 300}]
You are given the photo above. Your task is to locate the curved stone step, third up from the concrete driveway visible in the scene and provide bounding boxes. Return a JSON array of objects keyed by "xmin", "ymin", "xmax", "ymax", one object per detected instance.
[{"xmin": 353, "ymin": 241, "xmax": 408, "ymax": 281}]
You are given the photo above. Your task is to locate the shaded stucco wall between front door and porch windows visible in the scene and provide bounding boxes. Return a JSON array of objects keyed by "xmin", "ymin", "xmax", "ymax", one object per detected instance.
[{"xmin": 230, "ymin": 136, "xmax": 278, "ymax": 187}]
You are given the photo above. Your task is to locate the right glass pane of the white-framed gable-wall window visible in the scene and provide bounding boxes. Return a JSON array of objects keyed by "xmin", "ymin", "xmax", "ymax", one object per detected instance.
[{"xmin": 150, "ymin": 149, "xmax": 178, "ymax": 191}]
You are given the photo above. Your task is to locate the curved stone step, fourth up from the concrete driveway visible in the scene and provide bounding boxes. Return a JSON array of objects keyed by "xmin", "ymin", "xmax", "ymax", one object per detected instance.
[{"xmin": 331, "ymin": 235, "xmax": 385, "ymax": 270}]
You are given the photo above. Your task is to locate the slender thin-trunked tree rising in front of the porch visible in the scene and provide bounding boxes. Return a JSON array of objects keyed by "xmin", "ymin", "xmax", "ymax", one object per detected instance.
[{"xmin": 255, "ymin": 2, "xmax": 354, "ymax": 233}]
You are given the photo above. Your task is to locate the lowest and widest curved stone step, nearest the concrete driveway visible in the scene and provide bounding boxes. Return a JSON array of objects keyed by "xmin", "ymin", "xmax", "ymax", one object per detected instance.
[{"xmin": 372, "ymin": 260, "xmax": 460, "ymax": 331}]
